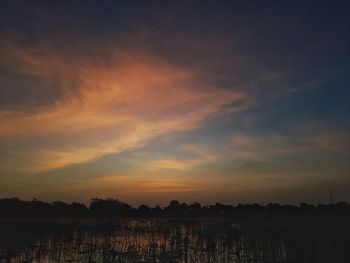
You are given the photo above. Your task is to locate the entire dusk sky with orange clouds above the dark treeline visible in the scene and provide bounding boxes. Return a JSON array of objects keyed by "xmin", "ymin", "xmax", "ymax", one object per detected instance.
[{"xmin": 0, "ymin": 0, "xmax": 350, "ymax": 205}]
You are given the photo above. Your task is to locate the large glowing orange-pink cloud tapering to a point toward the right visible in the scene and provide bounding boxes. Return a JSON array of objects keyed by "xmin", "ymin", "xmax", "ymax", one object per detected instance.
[{"xmin": 0, "ymin": 41, "xmax": 246, "ymax": 172}]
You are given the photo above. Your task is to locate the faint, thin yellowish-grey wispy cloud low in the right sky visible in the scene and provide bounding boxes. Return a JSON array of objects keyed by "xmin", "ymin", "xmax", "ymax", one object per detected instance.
[{"xmin": 144, "ymin": 127, "xmax": 350, "ymax": 173}]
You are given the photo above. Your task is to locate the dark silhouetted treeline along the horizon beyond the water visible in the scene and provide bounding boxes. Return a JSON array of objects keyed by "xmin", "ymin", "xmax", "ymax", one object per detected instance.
[{"xmin": 0, "ymin": 198, "xmax": 350, "ymax": 218}]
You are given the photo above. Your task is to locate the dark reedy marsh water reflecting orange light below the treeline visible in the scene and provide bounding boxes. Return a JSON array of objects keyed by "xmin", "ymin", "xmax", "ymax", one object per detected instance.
[{"xmin": 0, "ymin": 219, "xmax": 350, "ymax": 263}]
